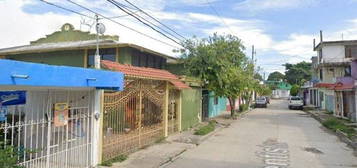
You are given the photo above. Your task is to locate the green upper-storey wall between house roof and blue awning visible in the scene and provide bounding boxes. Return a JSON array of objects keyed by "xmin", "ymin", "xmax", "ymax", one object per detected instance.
[{"xmin": 6, "ymin": 50, "xmax": 84, "ymax": 67}]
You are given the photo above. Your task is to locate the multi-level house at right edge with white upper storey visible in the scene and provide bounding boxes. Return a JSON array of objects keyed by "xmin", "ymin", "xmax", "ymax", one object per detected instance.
[{"xmin": 313, "ymin": 38, "xmax": 357, "ymax": 121}]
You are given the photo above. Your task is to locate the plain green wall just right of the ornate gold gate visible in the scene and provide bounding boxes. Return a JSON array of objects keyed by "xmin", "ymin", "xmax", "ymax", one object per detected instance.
[{"xmin": 181, "ymin": 88, "xmax": 202, "ymax": 130}]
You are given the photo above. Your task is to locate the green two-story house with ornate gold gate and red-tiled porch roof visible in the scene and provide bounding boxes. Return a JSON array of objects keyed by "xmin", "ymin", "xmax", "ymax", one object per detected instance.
[{"xmin": 0, "ymin": 24, "xmax": 196, "ymax": 160}]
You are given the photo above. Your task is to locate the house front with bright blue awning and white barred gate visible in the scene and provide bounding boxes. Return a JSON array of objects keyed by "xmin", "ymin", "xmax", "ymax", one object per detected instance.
[{"xmin": 0, "ymin": 59, "xmax": 124, "ymax": 168}]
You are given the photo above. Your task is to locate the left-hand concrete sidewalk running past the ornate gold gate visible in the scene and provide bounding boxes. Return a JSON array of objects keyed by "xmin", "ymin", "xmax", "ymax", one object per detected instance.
[{"xmin": 101, "ymin": 111, "xmax": 248, "ymax": 168}]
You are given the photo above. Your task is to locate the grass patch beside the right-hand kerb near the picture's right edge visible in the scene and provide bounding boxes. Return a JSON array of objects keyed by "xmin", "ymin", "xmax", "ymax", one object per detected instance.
[{"xmin": 322, "ymin": 117, "xmax": 357, "ymax": 138}]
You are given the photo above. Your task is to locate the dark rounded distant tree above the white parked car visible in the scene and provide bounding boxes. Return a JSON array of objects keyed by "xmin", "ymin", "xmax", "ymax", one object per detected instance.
[{"xmin": 284, "ymin": 61, "xmax": 311, "ymax": 85}]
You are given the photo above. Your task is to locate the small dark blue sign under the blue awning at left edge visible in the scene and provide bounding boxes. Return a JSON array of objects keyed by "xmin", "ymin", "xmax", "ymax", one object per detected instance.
[{"xmin": 0, "ymin": 91, "xmax": 26, "ymax": 106}]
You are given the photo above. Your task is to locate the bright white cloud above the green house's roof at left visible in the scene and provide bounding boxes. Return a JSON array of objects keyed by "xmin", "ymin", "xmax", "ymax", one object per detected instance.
[{"xmin": 0, "ymin": 0, "xmax": 178, "ymax": 55}]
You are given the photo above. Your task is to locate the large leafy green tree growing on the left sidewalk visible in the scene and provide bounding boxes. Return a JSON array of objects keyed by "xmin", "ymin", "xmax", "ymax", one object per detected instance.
[{"xmin": 180, "ymin": 33, "xmax": 250, "ymax": 118}]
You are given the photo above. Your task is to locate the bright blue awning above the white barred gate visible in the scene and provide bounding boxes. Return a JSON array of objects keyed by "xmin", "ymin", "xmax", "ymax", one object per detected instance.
[{"xmin": 0, "ymin": 59, "xmax": 124, "ymax": 90}]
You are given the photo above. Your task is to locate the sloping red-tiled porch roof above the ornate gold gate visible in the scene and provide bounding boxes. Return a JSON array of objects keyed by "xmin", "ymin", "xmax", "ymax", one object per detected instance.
[{"xmin": 101, "ymin": 60, "xmax": 190, "ymax": 89}]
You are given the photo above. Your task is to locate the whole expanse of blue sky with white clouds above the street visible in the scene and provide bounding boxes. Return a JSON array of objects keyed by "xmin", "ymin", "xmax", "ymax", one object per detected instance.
[{"xmin": 0, "ymin": 0, "xmax": 357, "ymax": 77}]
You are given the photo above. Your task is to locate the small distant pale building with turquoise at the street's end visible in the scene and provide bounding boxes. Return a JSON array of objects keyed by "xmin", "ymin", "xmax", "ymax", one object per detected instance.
[{"xmin": 265, "ymin": 81, "xmax": 292, "ymax": 99}]
